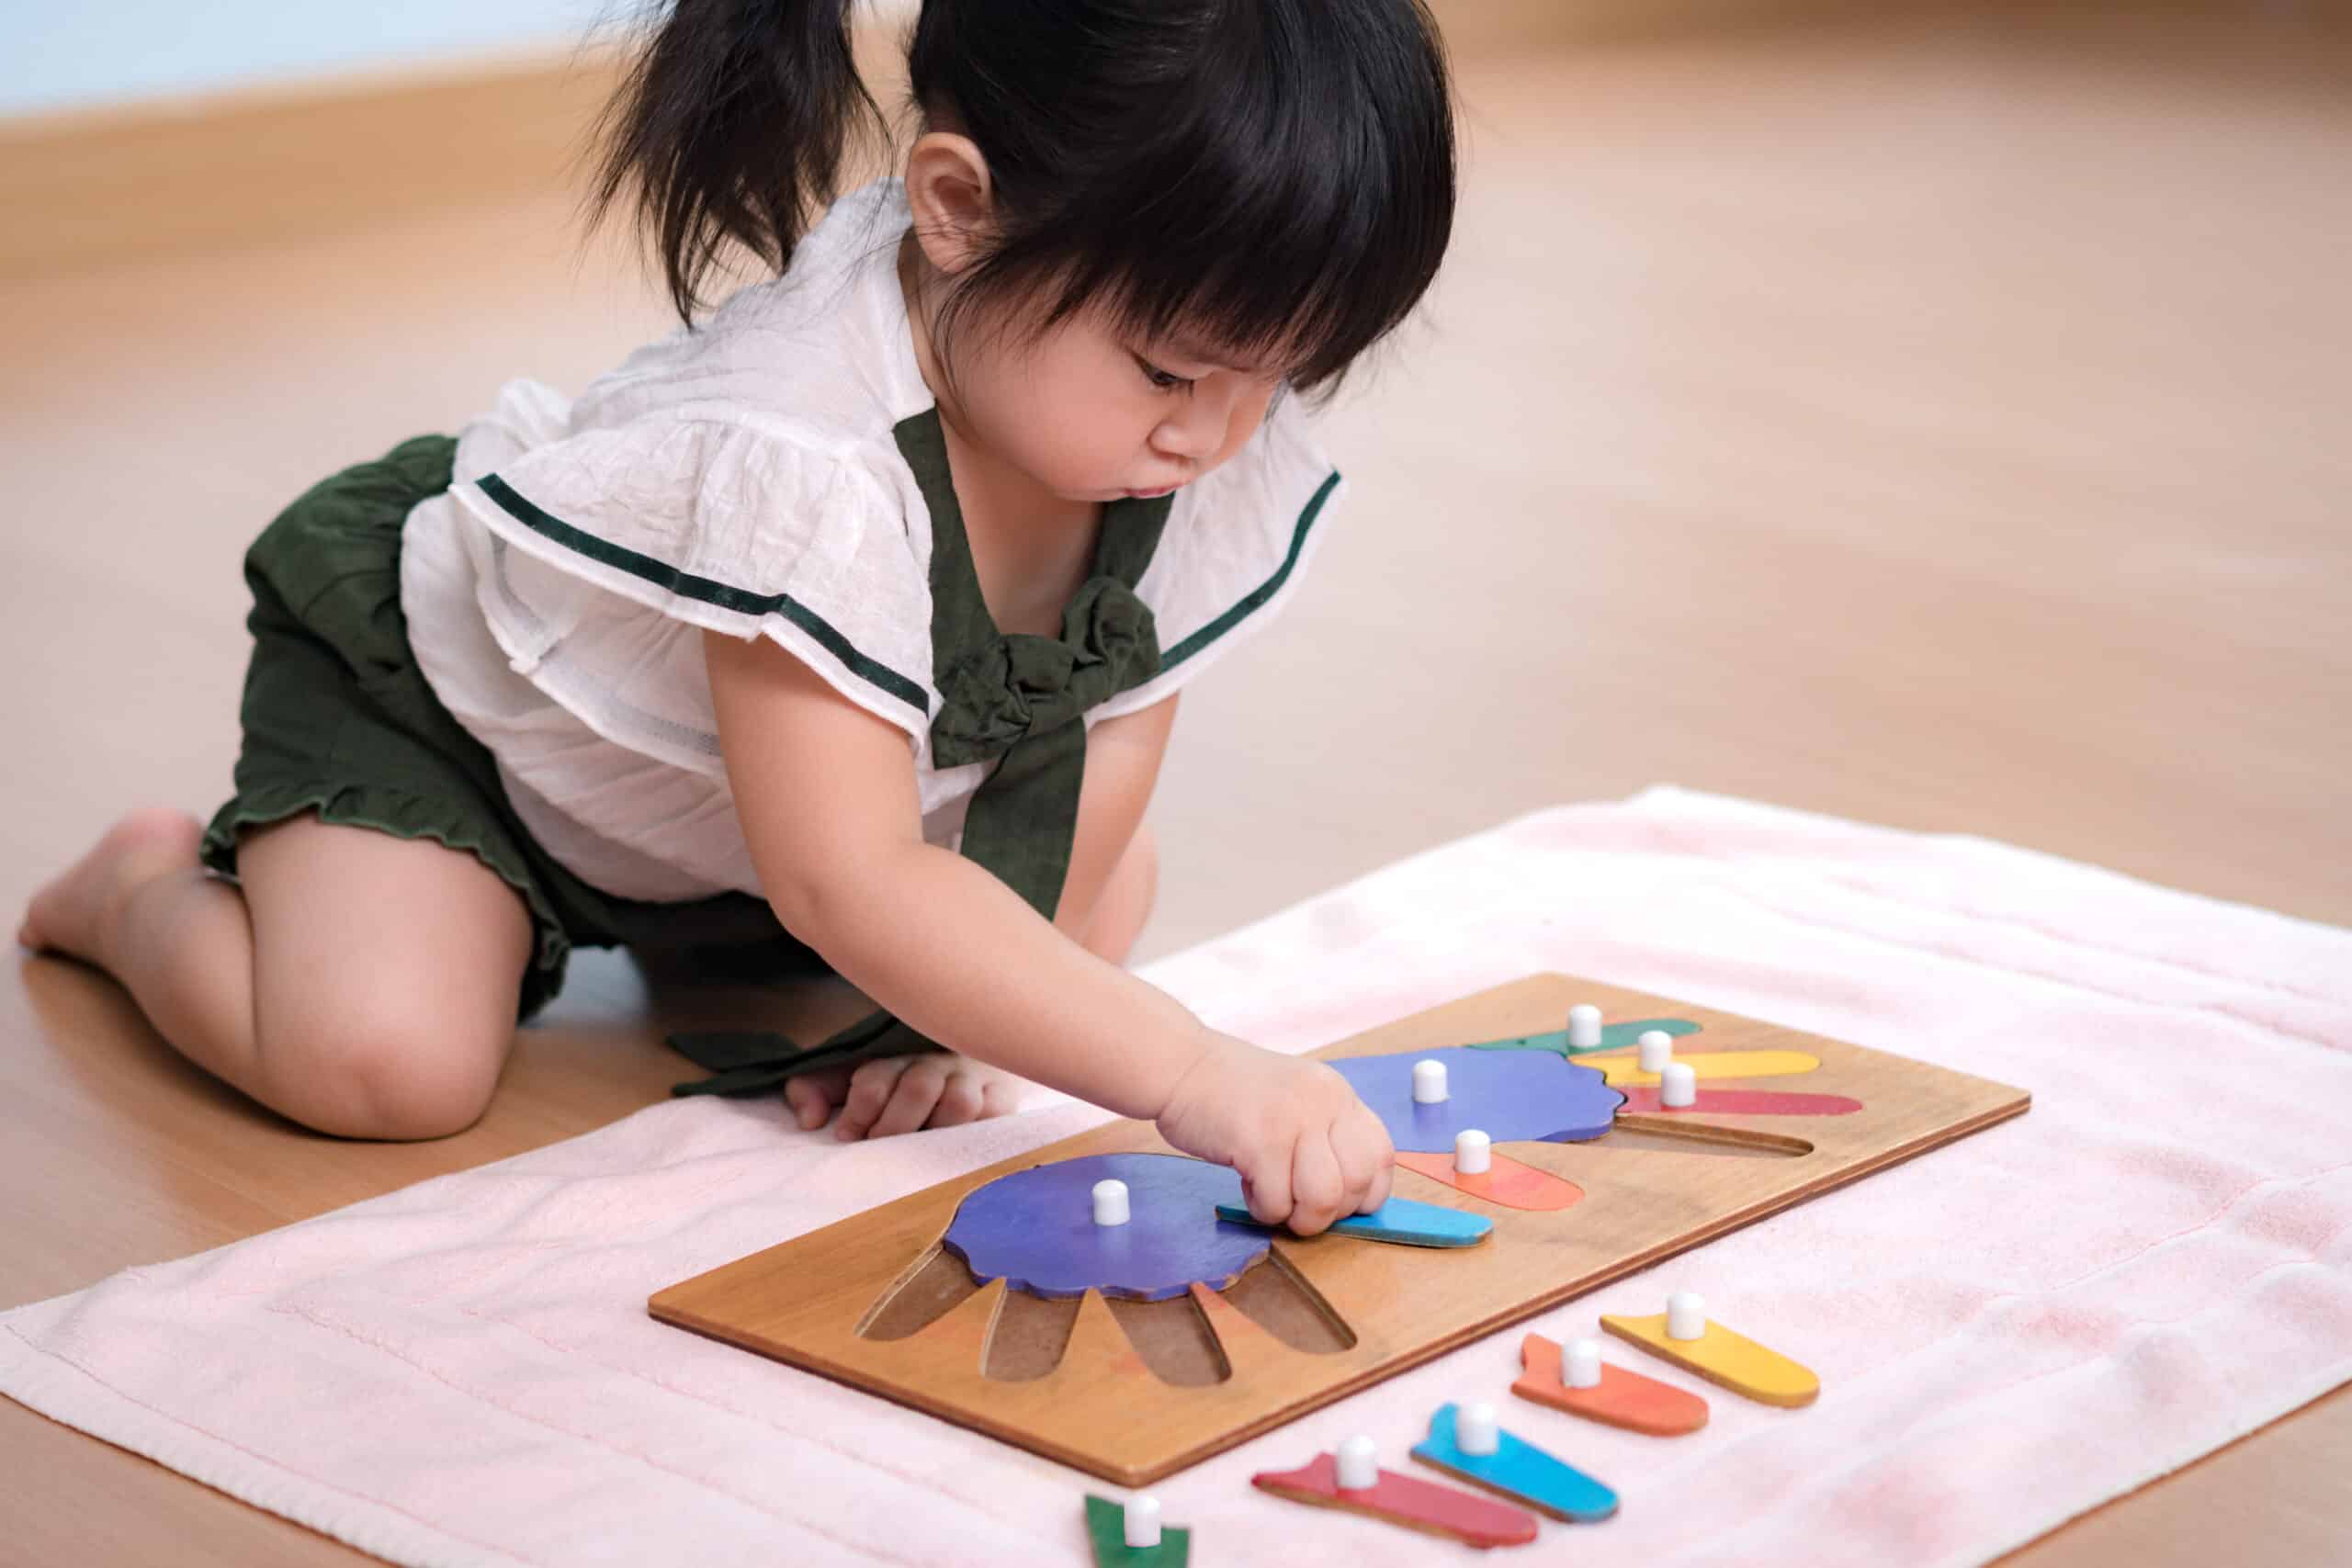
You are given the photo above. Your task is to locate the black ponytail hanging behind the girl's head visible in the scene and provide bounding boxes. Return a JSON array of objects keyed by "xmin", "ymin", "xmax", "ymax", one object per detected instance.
[{"xmin": 588, "ymin": 0, "xmax": 882, "ymax": 324}]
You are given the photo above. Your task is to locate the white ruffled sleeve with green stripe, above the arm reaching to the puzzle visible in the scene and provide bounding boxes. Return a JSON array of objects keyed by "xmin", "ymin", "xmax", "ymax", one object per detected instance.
[{"xmin": 452, "ymin": 412, "xmax": 932, "ymax": 745}]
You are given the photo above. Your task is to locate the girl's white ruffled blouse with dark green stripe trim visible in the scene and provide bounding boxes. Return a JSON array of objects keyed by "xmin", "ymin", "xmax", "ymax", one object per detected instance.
[{"xmin": 400, "ymin": 181, "xmax": 1343, "ymax": 900}]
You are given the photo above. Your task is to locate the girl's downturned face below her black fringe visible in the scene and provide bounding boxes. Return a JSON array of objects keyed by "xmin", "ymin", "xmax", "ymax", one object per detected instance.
[{"xmin": 957, "ymin": 310, "xmax": 1282, "ymax": 514}]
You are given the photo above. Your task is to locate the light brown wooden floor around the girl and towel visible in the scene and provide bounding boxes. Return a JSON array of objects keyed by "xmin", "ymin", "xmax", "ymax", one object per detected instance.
[{"xmin": 0, "ymin": 7, "xmax": 2352, "ymax": 1568}]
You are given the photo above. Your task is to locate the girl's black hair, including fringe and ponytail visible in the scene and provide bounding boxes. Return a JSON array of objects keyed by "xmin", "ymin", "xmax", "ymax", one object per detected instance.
[{"xmin": 593, "ymin": 0, "xmax": 1453, "ymax": 390}]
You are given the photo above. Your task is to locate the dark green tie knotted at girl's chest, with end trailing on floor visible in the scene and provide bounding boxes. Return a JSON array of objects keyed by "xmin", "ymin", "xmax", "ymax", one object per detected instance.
[{"xmin": 671, "ymin": 409, "xmax": 1173, "ymax": 1096}]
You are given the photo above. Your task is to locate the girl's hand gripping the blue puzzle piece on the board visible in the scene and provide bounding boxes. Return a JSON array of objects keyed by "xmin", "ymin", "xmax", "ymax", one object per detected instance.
[{"xmin": 1159, "ymin": 1034, "xmax": 1395, "ymax": 1236}]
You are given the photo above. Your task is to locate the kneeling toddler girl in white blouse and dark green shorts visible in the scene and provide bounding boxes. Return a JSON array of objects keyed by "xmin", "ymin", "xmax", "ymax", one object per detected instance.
[{"xmin": 21, "ymin": 0, "xmax": 1453, "ymax": 1232}]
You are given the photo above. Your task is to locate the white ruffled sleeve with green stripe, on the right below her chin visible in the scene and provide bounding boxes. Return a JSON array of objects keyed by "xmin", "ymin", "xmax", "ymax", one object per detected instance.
[{"xmin": 1093, "ymin": 398, "xmax": 1345, "ymax": 717}]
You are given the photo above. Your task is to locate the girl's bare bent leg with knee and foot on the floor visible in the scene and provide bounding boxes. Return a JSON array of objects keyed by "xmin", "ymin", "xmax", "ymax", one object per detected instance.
[{"xmin": 21, "ymin": 811, "xmax": 532, "ymax": 1138}]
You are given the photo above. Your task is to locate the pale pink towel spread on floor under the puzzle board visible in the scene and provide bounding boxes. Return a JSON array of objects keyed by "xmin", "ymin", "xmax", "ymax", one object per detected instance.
[{"xmin": 0, "ymin": 790, "xmax": 2352, "ymax": 1568}]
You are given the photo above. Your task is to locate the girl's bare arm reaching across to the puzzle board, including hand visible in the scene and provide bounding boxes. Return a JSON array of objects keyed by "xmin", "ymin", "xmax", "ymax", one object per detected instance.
[{"xmin": 703, "ymin": 635, "xmax": 1390, "ymax": 1232}]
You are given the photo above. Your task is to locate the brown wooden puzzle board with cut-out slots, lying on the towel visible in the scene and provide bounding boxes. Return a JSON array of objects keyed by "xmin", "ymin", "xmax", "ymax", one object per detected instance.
[{"xmin": 650, "ymin": 976, "xmax": 2030, "ymax": 1485}]
